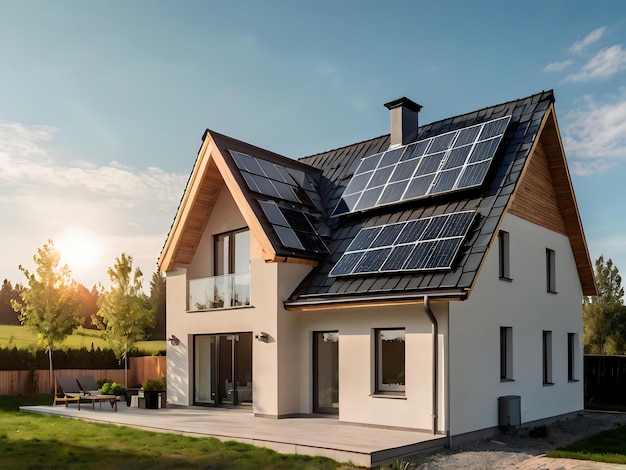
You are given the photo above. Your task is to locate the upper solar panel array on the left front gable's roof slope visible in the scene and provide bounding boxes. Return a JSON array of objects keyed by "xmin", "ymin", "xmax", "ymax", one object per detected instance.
[{"xmin": 229, "ymin": 150, "xmax": 315, "ymax": 206}]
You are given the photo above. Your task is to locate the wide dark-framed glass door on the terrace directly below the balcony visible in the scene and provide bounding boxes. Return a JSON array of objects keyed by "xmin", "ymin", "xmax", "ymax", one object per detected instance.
[{"xmin": 194, "ymin": 333, "xmax": 252, "ymax": 405}]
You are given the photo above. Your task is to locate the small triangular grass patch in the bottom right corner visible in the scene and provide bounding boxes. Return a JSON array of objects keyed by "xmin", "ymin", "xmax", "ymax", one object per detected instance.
[{"xmin": 546, "ymin": 426, "xmax": 626, "ymax": 464}]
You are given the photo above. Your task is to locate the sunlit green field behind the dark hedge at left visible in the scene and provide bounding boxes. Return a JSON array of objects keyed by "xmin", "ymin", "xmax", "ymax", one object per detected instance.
[{"xmin": 0, "ymin": 325, "xmax": 165, "ymax": 356}]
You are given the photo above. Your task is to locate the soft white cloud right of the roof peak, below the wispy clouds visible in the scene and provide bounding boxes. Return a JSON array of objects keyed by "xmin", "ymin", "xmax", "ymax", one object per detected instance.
[{"xmin": 563, "ymin": 93, "xmax": 626, "ymax": 175}]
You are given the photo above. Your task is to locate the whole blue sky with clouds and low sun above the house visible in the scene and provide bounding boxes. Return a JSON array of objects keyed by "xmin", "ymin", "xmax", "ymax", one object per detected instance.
[{"xmin": 0, "ymin": 0, "xmax": 626, "ymax": 287}]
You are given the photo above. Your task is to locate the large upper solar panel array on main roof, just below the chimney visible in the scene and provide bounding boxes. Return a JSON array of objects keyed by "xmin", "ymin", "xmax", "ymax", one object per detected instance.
[{"xmin": 332, "ymin": 116, "xmax": 511, "ymax": 215}]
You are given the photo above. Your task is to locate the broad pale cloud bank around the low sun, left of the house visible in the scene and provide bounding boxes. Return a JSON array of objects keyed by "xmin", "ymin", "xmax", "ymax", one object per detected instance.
[{"xmin": 0, "ymin": 122, "xmax": 188, "ymax": 288}]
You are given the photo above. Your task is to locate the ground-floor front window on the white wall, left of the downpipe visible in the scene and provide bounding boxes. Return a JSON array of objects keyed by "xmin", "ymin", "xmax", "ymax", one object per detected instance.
[{"xmin": 376, "ymin": 328, "xmax": 405, "ymax": 393}]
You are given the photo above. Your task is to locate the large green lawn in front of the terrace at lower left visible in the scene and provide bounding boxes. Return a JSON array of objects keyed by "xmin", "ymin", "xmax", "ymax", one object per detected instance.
[{"xmin": 0, "ymin": 395, "xmax": 352, "ymax": 470}]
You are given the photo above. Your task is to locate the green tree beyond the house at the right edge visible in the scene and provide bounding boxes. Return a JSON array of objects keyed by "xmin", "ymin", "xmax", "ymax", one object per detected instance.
[{"xmin": 583, "ymin": 255, "xmax": 626, "ymax": 354}]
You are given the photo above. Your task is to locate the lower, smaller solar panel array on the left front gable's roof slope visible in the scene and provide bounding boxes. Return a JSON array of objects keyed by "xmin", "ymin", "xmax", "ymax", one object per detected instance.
[{"xmin": 259, "ymin": 201, "xmax": 328, "ymax": 253}]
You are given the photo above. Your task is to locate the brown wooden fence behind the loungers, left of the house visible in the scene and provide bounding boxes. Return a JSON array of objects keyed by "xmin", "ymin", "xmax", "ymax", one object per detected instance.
[{"xmin": 0, "ymin": 356, "xmax": 166, "ymax": 396}]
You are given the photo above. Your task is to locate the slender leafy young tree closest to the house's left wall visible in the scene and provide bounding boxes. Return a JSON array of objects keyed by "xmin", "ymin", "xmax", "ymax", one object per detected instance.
[{"xmin": 96, "ymin": 253, "xmax": 155, "ymax": 386}]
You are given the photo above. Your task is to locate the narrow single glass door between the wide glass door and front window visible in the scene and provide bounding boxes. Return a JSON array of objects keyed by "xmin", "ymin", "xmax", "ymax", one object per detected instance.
[{"xmin": 313, "ymin": 331, "xmax": 339, "ymax": 414}]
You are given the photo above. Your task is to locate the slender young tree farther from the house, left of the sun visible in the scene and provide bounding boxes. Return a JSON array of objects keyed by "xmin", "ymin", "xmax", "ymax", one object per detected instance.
[{"xmin": 11, "ymin": 240, "xmax": 79, "ymax": 391}]
